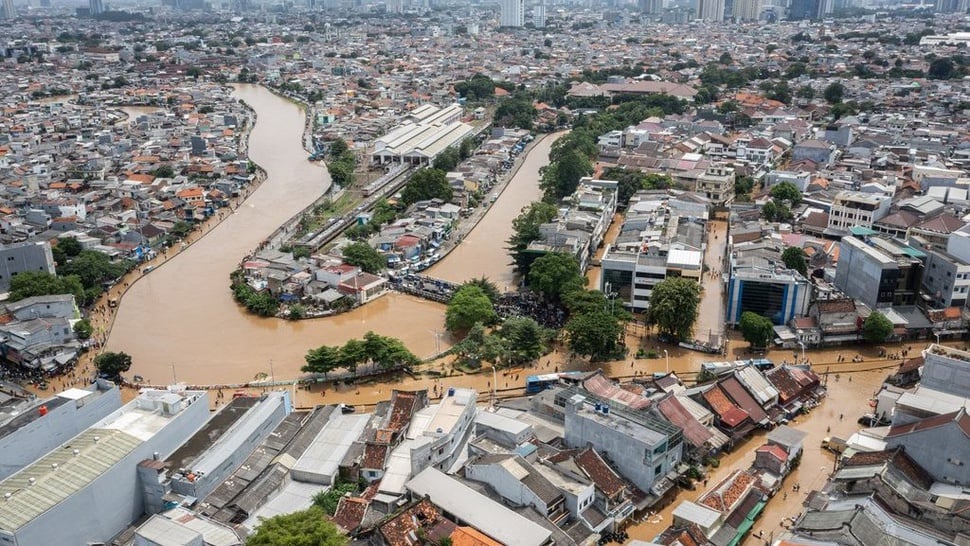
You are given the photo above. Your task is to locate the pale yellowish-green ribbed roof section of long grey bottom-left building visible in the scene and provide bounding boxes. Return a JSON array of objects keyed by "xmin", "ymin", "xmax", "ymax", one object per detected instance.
[{"xmin": 0, "ymin": 429, "xmax": 142, "ymax": 531}]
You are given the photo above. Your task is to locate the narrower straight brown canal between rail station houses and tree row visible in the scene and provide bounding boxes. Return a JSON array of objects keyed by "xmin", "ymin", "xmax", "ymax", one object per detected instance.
[{"xmin": 426, "ymin": 133, "xmax": 564, "ymax": 286}]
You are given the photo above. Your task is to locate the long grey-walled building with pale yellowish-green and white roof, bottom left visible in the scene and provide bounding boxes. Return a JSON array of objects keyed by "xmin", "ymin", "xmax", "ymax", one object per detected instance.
[{"xmin": 0, "ymin": 390, "xmax": 209, "ymax": 546}]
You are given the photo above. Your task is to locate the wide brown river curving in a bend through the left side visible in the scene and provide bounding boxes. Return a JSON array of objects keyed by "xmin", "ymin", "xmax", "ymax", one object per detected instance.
[{"xmin": 106, "ymin": 85, "xmax": 447, "ymax": 384}]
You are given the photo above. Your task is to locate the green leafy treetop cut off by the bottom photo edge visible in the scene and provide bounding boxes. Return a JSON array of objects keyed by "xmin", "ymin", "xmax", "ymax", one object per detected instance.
[{"xmin": 246, "ymin": 506, "xmax": 347, "ymax": 546}]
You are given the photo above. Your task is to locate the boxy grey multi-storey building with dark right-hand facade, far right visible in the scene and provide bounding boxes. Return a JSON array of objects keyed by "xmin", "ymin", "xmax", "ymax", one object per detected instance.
[{"xmin": 835, "ymin": 237, "xmax": 926, "ymax": 309}]
